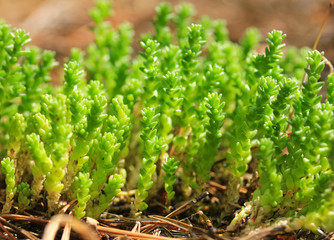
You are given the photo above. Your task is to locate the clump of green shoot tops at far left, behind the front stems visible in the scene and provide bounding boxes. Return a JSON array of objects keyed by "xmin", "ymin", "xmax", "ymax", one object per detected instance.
[{"xmin": 0, "ymin": 22, "xmax": 57, "ymax": 143}]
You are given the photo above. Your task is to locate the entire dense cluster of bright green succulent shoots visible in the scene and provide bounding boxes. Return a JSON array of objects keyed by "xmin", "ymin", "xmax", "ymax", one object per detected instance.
[{"xmin": 0, "ymin": 0, "xmax": 334, "ymax": 231}]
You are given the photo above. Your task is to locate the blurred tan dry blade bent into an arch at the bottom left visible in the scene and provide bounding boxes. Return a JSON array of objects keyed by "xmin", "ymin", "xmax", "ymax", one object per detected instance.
[{"xmin": 42, "ymin": 214, "xmax": 99, "ymax": 240}]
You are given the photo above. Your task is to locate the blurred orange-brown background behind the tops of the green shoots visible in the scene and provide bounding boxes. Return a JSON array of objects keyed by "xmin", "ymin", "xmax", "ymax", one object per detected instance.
[{"xmin": 0, "ymin": 0, "xmax": 334, "ymax": 83}]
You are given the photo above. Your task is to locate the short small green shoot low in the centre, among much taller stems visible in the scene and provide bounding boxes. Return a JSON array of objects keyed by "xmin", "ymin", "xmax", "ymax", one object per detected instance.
[{"xmin": 161, "ymin": 157, "xmax": 180, "ymax": 200}]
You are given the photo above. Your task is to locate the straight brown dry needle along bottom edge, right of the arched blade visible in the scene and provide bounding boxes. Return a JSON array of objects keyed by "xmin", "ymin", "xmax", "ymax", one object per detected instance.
[{"xmin": 97, "ymin": 226, "xmax": 186, "ymax": 240}]
